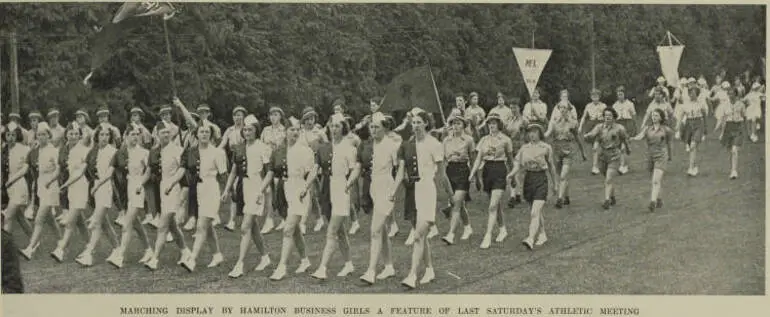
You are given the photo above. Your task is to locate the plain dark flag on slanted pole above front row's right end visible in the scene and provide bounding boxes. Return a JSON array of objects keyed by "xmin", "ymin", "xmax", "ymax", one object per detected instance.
[{"xmin": 381, "ymin": 66, "xmax": 442, "ymax": 113}]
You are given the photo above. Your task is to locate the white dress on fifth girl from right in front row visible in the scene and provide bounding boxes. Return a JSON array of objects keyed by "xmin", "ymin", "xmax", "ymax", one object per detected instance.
[{"xmin": 243, "ymin": 140, "xmax": 272, "ymax": 216}]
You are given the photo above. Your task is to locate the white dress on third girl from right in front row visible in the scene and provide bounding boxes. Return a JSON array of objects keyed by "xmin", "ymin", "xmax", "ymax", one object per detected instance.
[{"xmin": 329, "ymin": 140, "xmax": 357, "ymax": 216}]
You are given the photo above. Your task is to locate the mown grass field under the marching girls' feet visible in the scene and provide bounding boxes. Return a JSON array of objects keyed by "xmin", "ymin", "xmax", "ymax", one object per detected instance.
[{"xmin": 10, "ymin": 123, "xmax": 766, "ymax": 295}]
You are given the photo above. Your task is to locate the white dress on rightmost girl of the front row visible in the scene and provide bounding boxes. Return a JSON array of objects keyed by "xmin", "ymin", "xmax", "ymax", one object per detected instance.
[{"xmin": 414, "ymin": 135, "xmax": 444, "ymax": 224}]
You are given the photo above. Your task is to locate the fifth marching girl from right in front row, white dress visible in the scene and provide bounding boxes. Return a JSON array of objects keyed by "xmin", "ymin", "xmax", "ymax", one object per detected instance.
[{"xmin": 222, "ymin": 115, "xmax": 273, "ymax": 278}]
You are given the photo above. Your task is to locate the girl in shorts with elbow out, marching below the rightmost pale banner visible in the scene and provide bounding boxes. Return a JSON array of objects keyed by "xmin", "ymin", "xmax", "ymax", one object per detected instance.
[{"xmin": 631, "ymin": 108, "xmax": 672, "ymax": 212}]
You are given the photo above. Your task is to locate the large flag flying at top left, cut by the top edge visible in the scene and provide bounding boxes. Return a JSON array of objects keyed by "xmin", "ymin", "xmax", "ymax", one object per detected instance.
[{"xmin": 83, "ymin": 2, "xmax": 176, "ymax": 84}]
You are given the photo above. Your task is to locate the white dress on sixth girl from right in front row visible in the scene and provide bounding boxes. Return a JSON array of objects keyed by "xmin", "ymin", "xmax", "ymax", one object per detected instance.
[{"xmin": 197, "ymin": 144, "xmax": 227, "ymax": 221}]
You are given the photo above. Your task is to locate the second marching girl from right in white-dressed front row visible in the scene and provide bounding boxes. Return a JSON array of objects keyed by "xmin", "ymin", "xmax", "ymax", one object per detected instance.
[{"xmin": 361, "ymin": 112, "xmax": 401, "ymax": 284}]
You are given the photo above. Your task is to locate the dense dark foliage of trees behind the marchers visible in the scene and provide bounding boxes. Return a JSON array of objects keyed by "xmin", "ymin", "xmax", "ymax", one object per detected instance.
[{"xmin": 0, "ymin": 3, "xmax": 765, "ymax": 128}]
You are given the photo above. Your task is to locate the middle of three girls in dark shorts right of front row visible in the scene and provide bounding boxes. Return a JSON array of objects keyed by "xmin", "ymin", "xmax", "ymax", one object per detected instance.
[{"xmin": 468, "ymin": 115, "xmax": 513, "ymax": 249}]
